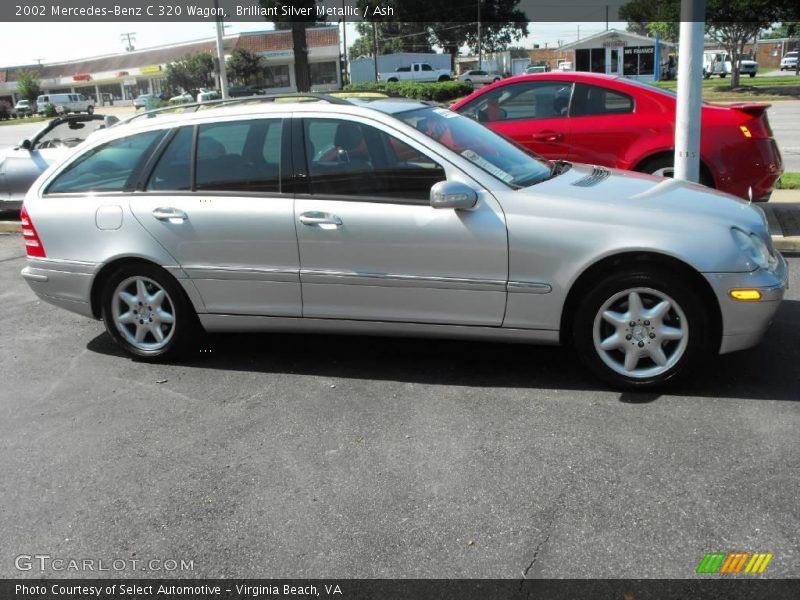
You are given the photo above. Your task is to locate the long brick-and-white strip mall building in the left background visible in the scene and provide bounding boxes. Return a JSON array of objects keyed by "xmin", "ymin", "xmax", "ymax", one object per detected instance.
[{"xmin": 0, "ymin": 27, "xmax": 341, "ymax": 105}]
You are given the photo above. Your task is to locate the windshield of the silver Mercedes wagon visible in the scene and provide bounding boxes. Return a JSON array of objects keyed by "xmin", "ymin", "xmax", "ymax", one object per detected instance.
[{"xmin": 395, "ymin": 108, "xmax": 554, "ymax": 187}]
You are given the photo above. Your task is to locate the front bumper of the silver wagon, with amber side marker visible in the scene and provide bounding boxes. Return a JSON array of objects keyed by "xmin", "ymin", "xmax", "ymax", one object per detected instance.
[{"xmin": 704, "ymin": 252, "xmax": 789, "ymax": 354}]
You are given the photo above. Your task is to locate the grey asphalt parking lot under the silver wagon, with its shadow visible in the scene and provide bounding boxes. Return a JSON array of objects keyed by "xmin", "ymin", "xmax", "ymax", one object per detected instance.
[{"xmin": 0, "ymin": 234, "xmax": 800, "ymax": 578}]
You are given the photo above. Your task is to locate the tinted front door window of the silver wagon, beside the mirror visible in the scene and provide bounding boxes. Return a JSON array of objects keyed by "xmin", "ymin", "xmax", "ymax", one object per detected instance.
[{"xmin": 305, "ymin": 119, "xmax": 446, "ymax": 202}]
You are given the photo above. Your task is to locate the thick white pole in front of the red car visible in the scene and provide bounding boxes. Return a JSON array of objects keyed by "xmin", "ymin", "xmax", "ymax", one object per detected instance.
[{"xmin": 674, "ymin": 0, "xmax": 706, "ymax": 182}]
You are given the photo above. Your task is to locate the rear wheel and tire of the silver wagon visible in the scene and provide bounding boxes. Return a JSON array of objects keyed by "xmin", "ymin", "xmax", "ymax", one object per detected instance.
[{"xmin": 101, "ymin": 263, "xmax": 199, "ymax": 362}]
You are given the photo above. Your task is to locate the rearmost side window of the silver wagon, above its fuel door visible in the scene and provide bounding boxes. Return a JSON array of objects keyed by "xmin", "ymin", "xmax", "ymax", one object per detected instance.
[{"xmin": 47, "ymin": 131, "xmax": 164, "ymax": 194}]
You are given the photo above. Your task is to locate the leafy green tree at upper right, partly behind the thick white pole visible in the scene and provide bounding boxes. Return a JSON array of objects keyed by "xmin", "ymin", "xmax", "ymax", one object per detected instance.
[{"xmin": 619, "ymin": 0, "xmax": 798, "ymax": 88}]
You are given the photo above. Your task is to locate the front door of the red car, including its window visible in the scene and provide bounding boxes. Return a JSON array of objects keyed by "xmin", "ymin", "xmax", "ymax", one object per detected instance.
[{"xmin": 458, "ymin": 80, "xmax": 573, "ymax": 159}]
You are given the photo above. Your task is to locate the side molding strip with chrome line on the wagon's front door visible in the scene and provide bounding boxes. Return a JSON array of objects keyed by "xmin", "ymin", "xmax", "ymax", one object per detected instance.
[{"xmin": 300, "ymin": 269, "xmax": 506, "ymax": 291}]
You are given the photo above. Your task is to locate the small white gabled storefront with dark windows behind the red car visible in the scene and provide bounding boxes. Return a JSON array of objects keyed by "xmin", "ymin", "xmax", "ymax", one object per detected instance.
[{"xmin": 560, "ymin": 29, "xmax": 674, "ymax": 80}]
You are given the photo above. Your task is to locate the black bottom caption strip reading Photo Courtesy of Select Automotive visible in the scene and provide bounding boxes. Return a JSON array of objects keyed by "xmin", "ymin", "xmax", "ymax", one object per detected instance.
[{"xmin": 0, "ymin": 576, "xmax": 800, "ymax": 600}]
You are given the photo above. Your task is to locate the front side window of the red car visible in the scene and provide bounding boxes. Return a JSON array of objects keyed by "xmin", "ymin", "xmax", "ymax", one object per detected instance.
[{"xmin": 459, "ymin": 81, "xmax": 572, "ymax": 123}]
